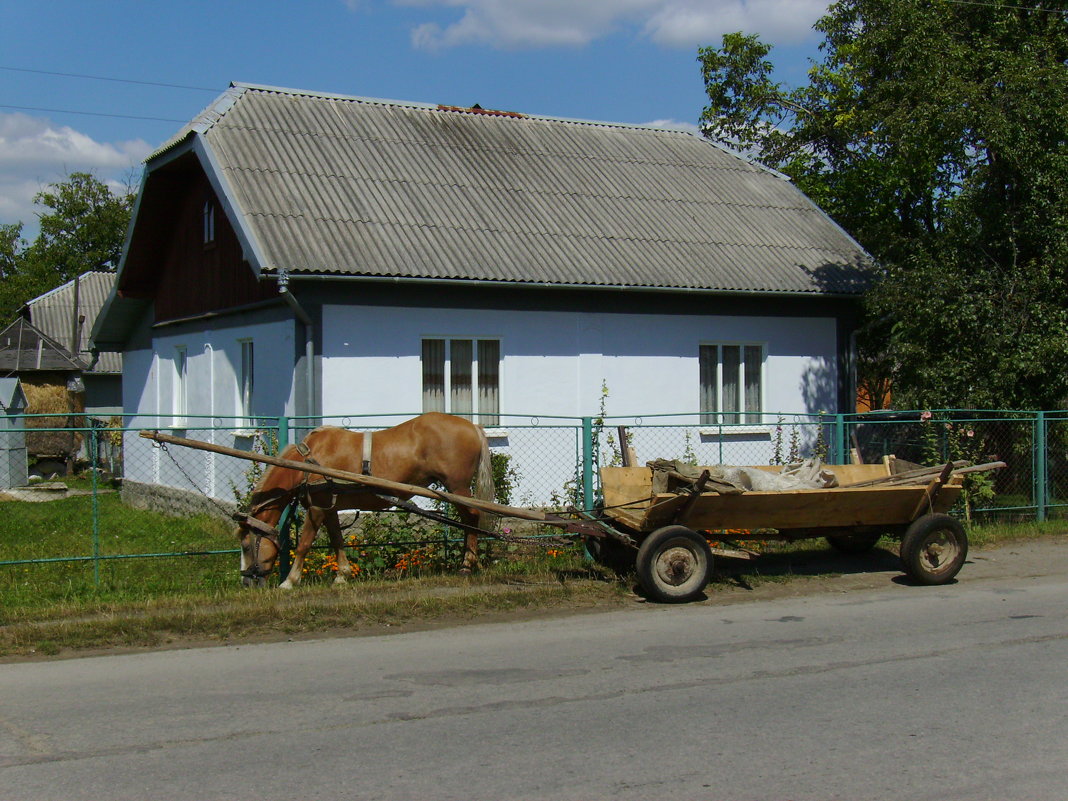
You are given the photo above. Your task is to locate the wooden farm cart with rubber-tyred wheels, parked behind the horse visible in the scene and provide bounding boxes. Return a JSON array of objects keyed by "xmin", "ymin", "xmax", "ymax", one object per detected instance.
[{"xmin": 590, "ymin": 461, "xmax": 1004, "ymax": 602}]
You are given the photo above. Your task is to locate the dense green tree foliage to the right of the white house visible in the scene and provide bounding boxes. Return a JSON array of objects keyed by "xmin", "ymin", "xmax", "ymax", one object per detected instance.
[{"xmin": 698, "ymin": 0, "xmax": 1068, "ymax": 408}]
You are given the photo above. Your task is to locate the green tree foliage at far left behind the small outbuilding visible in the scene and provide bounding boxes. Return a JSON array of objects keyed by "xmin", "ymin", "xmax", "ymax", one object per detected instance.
[{"xmin": 0, "ymin": 172, "xmax": 134, "ymax": 323}]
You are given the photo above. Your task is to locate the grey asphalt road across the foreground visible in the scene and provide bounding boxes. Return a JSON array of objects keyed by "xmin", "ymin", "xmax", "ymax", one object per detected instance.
[{"xmin": 0, "ymin": 543, "xmax": 1068, "ymax": 801}]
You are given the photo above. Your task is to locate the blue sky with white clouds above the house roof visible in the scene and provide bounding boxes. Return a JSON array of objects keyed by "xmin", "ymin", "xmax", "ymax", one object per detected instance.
[{"xmin": 0, "ymin": 0, "xmax": 827, "ymax": 236}]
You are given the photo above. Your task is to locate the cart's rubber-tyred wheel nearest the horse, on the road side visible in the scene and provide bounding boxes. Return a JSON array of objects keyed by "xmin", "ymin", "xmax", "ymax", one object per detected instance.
[{"xmin": 635, "ymin": 525, "xmax": 712, "ymax": 603}]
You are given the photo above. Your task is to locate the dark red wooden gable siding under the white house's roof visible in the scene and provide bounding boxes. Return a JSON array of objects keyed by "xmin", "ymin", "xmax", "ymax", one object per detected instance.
[{"xmin": 152, "ymin": 170, "xmax": 278, "ymax": 323}]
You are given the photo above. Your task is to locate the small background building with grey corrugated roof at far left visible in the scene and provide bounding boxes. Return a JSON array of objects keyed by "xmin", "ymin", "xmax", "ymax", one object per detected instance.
[{"xmin": 22, "ymin": 270, "xmax": 123, "ymax": 419}]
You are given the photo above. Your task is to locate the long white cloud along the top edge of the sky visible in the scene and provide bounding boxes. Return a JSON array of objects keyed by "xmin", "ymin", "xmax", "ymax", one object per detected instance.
[{"xmin": 393, "ymin": 0, "xmax": 828, "ymax": 49}]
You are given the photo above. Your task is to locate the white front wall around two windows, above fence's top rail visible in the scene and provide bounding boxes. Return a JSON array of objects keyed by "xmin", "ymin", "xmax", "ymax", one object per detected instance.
[{"xmin": 323, "ymin": 305, "xmax": 837, "ymax": 417}]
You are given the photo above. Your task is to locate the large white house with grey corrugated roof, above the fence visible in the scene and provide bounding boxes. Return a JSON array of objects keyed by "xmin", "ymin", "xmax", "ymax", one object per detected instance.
[{"xmin": 92, "ymin": 84, "xmax": 868, "ymax": 504}]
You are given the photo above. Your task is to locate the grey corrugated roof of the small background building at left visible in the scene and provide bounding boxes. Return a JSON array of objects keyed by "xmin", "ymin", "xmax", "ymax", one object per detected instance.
[{"xmin": 26, "ymin": 271, "xmax": 123, "ymax": 373}]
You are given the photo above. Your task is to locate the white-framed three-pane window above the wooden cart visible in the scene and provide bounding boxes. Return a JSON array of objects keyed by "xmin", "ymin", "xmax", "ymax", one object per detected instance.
[{"xmin": 700, "ymin": 344, "xmax": 764, "ymax": 424}]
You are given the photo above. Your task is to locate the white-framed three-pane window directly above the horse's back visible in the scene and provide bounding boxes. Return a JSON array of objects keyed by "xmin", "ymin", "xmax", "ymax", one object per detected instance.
[{"xmin": 422, "ymin": 339, "xmax": 501, "ymax": 425}]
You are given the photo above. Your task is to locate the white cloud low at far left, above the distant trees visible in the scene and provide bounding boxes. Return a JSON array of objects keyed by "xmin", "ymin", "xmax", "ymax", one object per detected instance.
[{"xmin": 0, "ymin": 113, "xmax": 153, "ymax": 238}]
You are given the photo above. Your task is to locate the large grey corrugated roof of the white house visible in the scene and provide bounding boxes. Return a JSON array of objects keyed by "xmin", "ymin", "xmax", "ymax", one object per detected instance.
[{"xmin": 173, "ymin": 84, "xmax": 867, "ymax": 295}]
